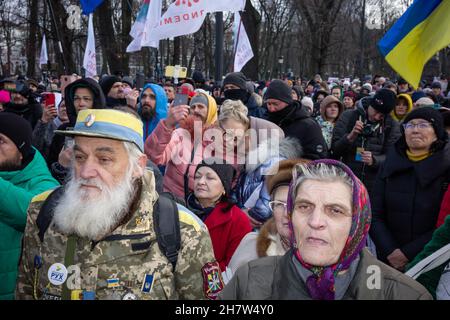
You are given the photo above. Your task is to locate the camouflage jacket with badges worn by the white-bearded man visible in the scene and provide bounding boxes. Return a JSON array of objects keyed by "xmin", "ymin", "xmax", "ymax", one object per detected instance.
[{"xmin": 16, "ymin": 172, "xmax": 223, "ymax": 300}]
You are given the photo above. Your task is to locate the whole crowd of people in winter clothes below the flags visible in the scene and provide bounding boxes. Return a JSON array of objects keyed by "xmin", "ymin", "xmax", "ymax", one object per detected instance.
[{"xmin": 0, "ymin": 71, "xmax": 450, "ymax": 300}]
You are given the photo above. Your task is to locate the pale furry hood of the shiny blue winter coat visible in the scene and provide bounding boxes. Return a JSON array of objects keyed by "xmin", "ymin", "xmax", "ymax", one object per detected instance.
[{"xmin": 245, "ymin": 136, "xmax": 303, "ymax": 172}]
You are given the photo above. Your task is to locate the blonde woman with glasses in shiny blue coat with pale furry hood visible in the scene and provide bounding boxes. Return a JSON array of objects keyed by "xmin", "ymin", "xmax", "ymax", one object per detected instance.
[{"xmin": 219, "ymin": 100, "xmax": 302, "ymax": 228}]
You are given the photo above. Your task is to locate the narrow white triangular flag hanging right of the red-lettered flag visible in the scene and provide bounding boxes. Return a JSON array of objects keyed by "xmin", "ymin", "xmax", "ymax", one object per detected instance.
[{"xmin": 234, "ymin": 12, "xmax": 253, "ymax": 72}]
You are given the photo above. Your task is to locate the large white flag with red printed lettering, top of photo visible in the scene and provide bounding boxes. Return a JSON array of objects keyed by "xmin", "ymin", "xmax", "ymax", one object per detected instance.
[{"xmin": 143, "ymin": 0, "xmax": 245, "ymax": 45}]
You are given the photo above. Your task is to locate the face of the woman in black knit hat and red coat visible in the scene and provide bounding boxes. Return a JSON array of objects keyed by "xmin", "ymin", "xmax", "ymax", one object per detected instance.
[{"xmin": 194, "ymin": 167, "xmax": 225, "ymax": 203}]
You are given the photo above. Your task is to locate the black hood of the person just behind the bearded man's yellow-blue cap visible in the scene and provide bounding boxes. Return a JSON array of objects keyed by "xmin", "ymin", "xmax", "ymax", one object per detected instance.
[{"xmin": 64, "ymin": 78, "xmax": 106, "ymax": 127}]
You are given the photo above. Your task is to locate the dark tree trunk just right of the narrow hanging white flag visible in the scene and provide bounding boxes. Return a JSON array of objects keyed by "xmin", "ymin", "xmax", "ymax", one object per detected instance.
[{"xmin": 241, "ymin": 0, "xmax": 261, "ymax": 80}]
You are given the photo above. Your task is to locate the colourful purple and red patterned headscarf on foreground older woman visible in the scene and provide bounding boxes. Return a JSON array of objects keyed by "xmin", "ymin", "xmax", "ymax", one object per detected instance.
[{"xmin": 287, "ymin": 159, "xmax": 372, "ymax": 300}]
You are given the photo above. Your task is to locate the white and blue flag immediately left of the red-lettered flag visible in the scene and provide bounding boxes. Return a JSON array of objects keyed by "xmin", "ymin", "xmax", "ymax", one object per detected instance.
[{"xmin": 127, "ymin": 0, "xmax": 162, "ymax": 52}]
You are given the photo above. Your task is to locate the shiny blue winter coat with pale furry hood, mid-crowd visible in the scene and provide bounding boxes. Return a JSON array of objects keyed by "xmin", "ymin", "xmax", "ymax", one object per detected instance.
[{"xmin": 235, "ymin": 138, "xmax": 302, "ymax": 222}]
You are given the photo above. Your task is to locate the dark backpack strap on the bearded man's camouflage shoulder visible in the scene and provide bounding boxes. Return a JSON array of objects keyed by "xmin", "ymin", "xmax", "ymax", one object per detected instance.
[{"xmin": 153, "ymin": 195, "xmax": 181, "ymax": 271}]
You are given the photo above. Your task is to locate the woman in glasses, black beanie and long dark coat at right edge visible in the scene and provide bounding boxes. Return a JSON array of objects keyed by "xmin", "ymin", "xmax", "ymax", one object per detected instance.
[{"xmin": 370, "ymin": 107, "xmax": 450, "ymax": 270}]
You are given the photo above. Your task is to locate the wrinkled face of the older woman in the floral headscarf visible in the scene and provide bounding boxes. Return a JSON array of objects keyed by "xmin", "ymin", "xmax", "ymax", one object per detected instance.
[{"xmin": 292, "ymin": 180, "xmax": 352, "ymax": 267}]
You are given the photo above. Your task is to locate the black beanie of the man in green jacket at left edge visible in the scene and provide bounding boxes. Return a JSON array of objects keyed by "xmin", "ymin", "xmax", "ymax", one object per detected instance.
[{"xmin": 0, "ymin": 112, "xmax": 33, "ymax": 159}]
